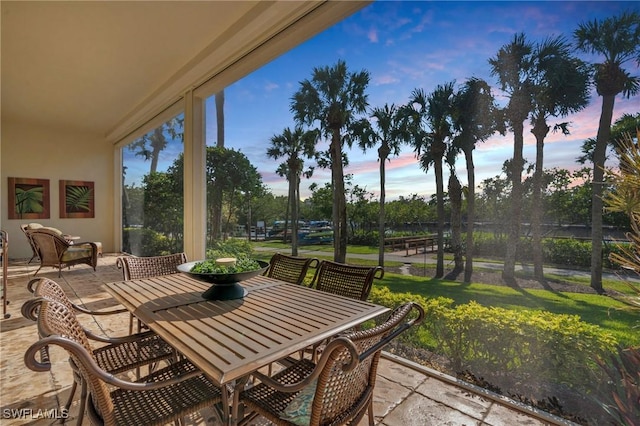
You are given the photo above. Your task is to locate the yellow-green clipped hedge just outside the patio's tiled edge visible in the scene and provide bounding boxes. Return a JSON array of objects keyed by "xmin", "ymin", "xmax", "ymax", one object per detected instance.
[{"xmin": 370, "ymin": 287, "xmax": 617, "ymax": 389}]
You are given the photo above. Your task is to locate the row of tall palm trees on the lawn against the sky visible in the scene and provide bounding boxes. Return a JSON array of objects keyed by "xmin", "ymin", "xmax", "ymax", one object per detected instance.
[{"xmin": 267, "ymin": 12, "xmax": 640, "ymax": 293}]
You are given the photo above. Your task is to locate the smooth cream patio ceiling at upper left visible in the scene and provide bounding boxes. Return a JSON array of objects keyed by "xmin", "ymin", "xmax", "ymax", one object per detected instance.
[{"xmin": 0, "ymin": 0, "xmax": 367, "ymax": 142}]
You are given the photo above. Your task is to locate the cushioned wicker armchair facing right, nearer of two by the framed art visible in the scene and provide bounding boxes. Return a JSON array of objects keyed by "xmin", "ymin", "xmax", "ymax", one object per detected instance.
[{"xmin": 26, "ymin": 228, "xmax": 98, "ymax": 277}]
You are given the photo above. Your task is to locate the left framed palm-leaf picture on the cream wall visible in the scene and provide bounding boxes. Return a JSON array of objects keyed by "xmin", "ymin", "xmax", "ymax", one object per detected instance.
[{"xmin": 7, "ymin": 177, "xmax": 50, "ymax": 219}]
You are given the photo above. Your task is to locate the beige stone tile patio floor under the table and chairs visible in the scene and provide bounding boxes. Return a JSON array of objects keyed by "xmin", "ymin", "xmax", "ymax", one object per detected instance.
[{"xmin": 0, "ymin": 253, "xmax": 571, "ymax": 426}]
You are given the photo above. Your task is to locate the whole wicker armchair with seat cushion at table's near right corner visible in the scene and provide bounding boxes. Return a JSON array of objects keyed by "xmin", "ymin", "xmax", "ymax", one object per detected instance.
[{"xmin": 239, "ymin": 302, "xmax": 424, "ymax": 426}]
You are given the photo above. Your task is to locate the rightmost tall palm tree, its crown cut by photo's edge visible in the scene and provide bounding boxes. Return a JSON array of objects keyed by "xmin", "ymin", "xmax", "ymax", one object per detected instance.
[{"xmin": 573, "ymin": 12, "xmax": 640, "ymax": 293}]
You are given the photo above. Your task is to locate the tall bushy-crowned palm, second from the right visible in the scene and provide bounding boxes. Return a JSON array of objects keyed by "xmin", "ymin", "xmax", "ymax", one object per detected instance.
[{"xmin": 531, "ymin": 37, "xmax": 589, "ymax": 282}]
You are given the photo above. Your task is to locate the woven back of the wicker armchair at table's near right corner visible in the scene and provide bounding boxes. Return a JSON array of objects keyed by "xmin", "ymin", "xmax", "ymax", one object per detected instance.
[{"xmin": 310, "ymin": 303, "xmax": 424, "ymax": 425}]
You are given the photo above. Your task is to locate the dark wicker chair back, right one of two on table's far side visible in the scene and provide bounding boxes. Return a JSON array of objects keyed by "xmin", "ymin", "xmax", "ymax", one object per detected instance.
[{"xmin": 312, "ymin": 260, "xmax": 384, "ymax": 300}]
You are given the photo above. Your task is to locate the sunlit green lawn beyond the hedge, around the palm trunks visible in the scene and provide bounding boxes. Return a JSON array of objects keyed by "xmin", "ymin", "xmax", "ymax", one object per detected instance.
[{"xmin": 254, "ymin": 241, "xmax": 640, "ymax": 346}]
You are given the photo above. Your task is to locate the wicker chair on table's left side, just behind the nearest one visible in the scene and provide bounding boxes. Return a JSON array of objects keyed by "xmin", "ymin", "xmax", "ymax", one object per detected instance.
[{"xmin": 22, "ymin": 278, "xmax": 177, "ymax": 418}]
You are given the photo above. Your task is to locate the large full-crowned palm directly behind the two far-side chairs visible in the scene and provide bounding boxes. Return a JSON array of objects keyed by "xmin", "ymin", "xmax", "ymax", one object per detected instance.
[{"xmin": 291, "ymin": 60, "xmax": 369, "ymax": 263}]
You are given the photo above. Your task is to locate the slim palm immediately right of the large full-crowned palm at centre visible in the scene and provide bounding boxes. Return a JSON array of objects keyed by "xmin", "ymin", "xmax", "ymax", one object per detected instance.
[{"xmin": 360, "ymin": 104, "xmax": 408, "ymax": 266}]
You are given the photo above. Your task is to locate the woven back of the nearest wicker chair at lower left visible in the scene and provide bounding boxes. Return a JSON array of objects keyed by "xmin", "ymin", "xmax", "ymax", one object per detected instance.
[{"xmin": 38, "ymin": 298, "xmax": 115, "ymax": 425}]
